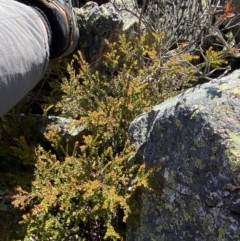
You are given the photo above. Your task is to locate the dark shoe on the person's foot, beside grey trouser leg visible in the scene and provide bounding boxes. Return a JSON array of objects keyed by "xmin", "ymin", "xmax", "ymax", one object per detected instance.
[{"xmin": 19, "ymin": 0, "xmax": 79, "ymax": 59}]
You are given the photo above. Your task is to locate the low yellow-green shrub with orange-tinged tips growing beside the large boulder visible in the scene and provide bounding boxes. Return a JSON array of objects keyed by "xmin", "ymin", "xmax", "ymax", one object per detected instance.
[{"xmin": 0, "ymin": 34, "xmax": 200, "ymax": 241}]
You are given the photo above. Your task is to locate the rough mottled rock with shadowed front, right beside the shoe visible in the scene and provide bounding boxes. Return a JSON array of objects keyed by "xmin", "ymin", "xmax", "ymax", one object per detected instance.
[{"xmin": 76, "ymin": 2, "xmax": 122, "ymax": 63}]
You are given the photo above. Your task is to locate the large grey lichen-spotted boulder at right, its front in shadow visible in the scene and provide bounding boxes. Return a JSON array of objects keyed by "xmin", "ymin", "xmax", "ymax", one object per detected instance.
[{"xmin": 127, "ymin": 70, "xmax": 240, "ymax": 241}]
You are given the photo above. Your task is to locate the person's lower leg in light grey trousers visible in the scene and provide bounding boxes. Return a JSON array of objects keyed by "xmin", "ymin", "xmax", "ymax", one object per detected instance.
[{"xmin": 0, "ymin": 0, "xmax": 49, "ymax": 117}]
